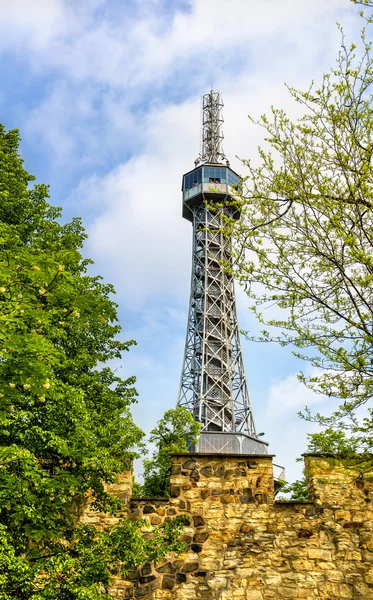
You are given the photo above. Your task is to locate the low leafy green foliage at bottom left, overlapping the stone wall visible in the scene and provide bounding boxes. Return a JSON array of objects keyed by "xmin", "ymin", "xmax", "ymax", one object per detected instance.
[{"xmin": 0, "ymin": 517, "xmax": 184, "ymax": 600}]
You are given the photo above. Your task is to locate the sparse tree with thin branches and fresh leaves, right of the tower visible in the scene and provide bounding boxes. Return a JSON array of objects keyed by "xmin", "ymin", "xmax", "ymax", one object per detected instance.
[{"xmin": 221, "ymin": 9, "xmax": 373, "ymax": 466}]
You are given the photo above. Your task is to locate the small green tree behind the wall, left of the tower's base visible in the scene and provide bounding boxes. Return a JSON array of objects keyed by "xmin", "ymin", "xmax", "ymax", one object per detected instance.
[{"xmin": 138, "ymin": 406, "xmax": 201, "ymax": 498}]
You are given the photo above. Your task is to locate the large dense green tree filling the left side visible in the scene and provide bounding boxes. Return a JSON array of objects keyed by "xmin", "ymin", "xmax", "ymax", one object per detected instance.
[{"xmin": 0, "ymin": 126, "xmax": 185, "ymax": 600}]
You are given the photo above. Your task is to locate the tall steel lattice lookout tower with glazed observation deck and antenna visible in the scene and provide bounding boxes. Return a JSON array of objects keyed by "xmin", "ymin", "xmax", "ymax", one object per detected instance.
[{"xmin": 177, "ymin": 91, "xmax": 268, "ymax": 454}]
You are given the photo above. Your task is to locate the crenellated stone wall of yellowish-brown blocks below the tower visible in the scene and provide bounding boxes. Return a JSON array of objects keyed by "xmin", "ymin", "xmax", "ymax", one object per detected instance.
[{"xmin": 86, "ymin": 454, "xmax": 373, "ymax": 600}]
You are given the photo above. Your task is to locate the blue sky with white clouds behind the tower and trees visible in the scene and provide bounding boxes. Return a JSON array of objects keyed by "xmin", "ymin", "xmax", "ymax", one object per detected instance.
[{"xmin": 0, "ymin": 0, "xmax": 362, "ymax": 481}]
